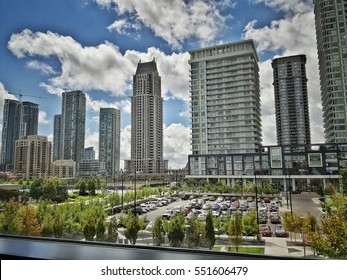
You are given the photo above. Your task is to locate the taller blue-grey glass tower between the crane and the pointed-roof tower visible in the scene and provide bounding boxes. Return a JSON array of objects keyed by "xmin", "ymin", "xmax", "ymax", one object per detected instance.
[{"xmin": 60, "ymin": 91, "xmax": 86, "ymax": 164}]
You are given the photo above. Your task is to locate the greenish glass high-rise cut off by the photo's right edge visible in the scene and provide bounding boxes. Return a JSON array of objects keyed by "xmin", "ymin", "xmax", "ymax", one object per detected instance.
[{"xmin": 313, "ymin": 0, "xmax": 347, "ymax": 143}]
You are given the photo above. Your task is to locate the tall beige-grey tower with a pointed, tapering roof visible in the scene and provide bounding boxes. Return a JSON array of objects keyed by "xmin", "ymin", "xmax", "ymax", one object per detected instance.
[{"xmin": 125, "ymin": 59, "xmax": 167, "ymax": 174}]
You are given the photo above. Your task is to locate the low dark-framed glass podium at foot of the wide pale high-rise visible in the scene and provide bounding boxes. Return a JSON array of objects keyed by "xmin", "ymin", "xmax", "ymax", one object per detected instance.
[{"xmin": 190, "ymin": 143, "xmax": 347, "ymax": 190}]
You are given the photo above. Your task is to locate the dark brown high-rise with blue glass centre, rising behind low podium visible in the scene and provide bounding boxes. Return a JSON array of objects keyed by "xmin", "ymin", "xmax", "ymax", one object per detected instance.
[{"xmin": 271, "ymin": 55, "xmax": 311, "ymax": 145}]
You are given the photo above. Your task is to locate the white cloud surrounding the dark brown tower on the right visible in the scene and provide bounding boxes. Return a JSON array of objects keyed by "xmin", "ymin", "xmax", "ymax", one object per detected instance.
[{"xmin": 243, "ymin": 8, "xmax": 324, "ymax": 144}]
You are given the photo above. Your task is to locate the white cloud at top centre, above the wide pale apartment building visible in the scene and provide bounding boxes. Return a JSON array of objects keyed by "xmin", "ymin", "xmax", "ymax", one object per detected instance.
[{"xmin": 96, "ymin": 0, "xmax": 230, "ymax": 49}]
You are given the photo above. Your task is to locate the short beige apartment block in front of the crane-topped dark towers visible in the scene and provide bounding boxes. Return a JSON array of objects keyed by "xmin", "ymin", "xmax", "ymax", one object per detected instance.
[{"xmin": 14, "ymin": 135, "xmax": 52, "ymax": 180}]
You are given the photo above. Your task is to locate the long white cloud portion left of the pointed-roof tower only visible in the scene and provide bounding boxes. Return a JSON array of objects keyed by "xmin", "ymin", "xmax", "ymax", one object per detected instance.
[{"xmin": 8, "ymin": 29, "xmax": 134, "ymax": 95}]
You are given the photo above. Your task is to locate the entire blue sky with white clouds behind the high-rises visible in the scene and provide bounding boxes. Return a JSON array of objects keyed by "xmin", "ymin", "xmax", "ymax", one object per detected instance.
[{"xmin": 0, "ymin": 0, "xmax": 324, "ymax": 168}]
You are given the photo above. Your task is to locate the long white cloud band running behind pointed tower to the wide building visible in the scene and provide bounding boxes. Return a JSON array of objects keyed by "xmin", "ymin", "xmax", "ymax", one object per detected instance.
[{"xmin": 8, "ymin": 29, "xmax": 189, "ymax": 102}]
